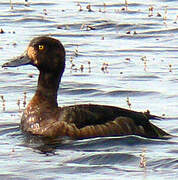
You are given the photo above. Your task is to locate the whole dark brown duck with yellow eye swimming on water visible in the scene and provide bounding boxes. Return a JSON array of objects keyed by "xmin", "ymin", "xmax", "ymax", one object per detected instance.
[{"xmin": 2, "ymin": 36, "xmax": 170, "ymax": 139}]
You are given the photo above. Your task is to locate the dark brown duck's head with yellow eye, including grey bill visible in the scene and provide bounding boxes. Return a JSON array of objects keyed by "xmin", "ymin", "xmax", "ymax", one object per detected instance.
[{"xmin": 2, "ymin": 36, "xmax": 65, "ymax": 73}]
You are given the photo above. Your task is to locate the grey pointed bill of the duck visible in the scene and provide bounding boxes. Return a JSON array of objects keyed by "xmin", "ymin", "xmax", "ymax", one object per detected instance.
[{"xmin": 2, "ymin": 53, "xmax": 30, "ymax": 67}]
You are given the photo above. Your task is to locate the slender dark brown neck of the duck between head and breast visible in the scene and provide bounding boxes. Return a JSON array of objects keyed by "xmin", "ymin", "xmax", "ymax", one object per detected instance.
[{"xmin": 31, "ymin": 71, "xmax": 63, "ymax": 108}]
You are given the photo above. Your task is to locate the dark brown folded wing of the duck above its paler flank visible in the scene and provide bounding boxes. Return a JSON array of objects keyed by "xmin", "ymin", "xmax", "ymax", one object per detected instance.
[{"xmin": 61, "ymin": 104, "xmax": 149, "ymax": 128}]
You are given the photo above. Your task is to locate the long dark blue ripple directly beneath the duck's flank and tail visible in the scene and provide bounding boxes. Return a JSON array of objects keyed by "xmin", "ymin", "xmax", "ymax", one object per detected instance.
[{"xmin": 52, "ymin": 135, "xmax": 174, "ymax": 154}]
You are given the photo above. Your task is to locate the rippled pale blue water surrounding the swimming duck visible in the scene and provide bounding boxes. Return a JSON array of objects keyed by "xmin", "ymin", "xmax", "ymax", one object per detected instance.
[{"xmin": 0, "ymin": 0, "xmax": 178, "ymax": 180}]
